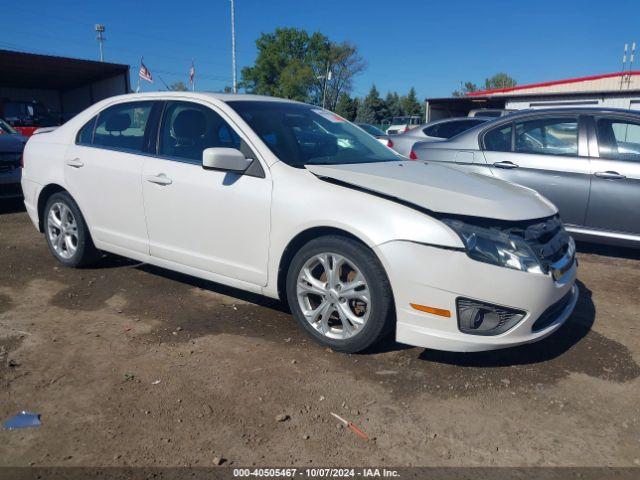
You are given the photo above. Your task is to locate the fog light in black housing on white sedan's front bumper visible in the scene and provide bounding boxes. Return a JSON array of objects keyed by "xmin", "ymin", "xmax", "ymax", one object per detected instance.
[{"xmin": 456, "ymin": 298, "xmax": 526, "ymax": 335}]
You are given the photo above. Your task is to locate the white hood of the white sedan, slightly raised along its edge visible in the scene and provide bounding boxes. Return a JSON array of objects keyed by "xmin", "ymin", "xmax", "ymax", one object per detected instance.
[{"xmin": 306, "ymin": 161, "xmax": 558, "ymax": 221}]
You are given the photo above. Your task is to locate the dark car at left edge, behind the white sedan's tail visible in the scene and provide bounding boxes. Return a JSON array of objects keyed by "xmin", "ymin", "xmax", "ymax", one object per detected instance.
[{"xmin": 0, "ymin": 118, "xmax": 27, "ymax": 198}]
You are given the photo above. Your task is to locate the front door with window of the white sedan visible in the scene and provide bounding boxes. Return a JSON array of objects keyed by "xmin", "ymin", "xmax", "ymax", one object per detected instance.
[{"xmin": 142, "ymin": 102, "xmax": 271, "ymax": 285}]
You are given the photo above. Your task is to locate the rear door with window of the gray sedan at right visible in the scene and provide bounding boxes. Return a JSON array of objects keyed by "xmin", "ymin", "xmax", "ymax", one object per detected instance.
[{"xmin": 483, "ymin": 114, "xmax": 591, "ymax": 225}]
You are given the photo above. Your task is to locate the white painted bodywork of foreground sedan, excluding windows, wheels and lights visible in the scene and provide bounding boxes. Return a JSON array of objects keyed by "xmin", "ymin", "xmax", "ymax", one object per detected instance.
[{"xmin": 22, "ymin": 92, "xmax": 577, "ymax": 351}]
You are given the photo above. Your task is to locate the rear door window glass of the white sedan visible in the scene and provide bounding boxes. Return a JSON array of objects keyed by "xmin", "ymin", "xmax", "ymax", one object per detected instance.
[{"xmin": 93, "ymin": 102, "xmax": 153, "ymax": 152}]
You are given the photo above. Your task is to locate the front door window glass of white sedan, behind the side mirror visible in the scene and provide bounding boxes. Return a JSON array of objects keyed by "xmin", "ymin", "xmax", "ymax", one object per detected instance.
[{"xmin": 159, "ymin": 102, "xmax": 242, "ymax": 164}]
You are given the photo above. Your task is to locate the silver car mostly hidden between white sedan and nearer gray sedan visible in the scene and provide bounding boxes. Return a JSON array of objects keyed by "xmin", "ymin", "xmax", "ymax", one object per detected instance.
[{"xmin": 389, "ymin": 117, "xmax": 491, "ymax": 157}]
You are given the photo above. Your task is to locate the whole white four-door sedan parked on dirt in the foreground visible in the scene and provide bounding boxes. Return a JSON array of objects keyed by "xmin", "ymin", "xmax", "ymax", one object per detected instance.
[{"xmin": 22, "ymin": 92, "xmax": 577, "ymax": 352}]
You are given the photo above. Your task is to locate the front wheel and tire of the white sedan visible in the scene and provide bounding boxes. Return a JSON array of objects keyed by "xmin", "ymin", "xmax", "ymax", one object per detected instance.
[{"xmin": 286, "ymin": 235, "xmax": 394, "ymax": 353}]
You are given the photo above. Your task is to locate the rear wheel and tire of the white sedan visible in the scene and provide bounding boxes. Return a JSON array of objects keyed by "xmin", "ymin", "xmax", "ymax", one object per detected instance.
[{"xmin": 44, "ymin": 192, "xmax": 100, "ymax": 268}]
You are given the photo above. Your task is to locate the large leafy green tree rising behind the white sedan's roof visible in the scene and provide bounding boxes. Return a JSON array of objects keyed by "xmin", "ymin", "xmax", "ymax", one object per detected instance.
[{"xmin": 241, "ymin": 28, "xmax": 365, "ymax": 110}]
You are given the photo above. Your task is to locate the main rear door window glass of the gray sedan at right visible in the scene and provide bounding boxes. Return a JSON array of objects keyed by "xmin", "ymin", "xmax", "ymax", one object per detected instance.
[{"xmin": 515, "ymin": 117, "xmax": 578, "ymax": 155}]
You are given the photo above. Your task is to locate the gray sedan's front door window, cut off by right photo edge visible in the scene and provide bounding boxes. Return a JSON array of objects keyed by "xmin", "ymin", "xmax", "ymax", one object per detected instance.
[{"xmin": 596, "ymin": 118, "xmax": 640, "ymax": 161}]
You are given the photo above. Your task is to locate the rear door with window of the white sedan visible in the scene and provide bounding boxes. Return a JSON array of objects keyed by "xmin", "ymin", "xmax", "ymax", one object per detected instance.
[{"xmin": 64, "ymin": 102, "xmax": 154, "ymax": 255}]
